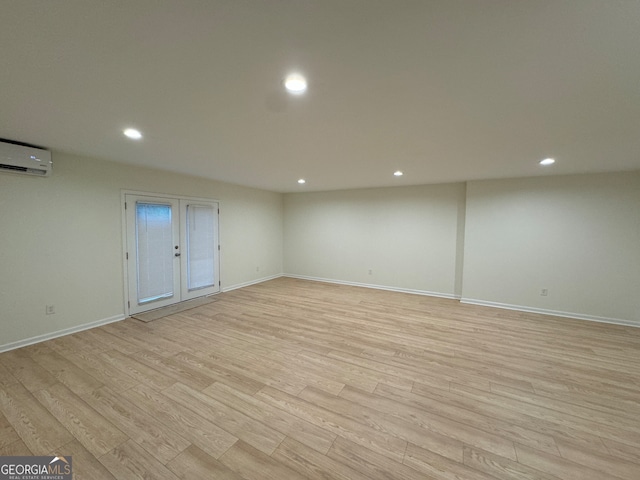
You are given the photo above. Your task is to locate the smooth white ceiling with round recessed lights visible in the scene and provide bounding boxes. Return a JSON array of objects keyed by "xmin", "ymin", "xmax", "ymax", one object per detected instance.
[{"xmin": 0, "ymin": 0, "xmax": 640, "ymax": 192}]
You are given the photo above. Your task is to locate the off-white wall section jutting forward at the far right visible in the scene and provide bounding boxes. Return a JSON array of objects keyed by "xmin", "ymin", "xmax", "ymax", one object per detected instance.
[{"xmin": 463, "ymin": 172, "xmax": 640, "ymax": 324}]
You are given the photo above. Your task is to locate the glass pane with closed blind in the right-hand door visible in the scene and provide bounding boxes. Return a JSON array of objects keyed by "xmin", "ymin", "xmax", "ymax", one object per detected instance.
[{"xmin": 187, "ymin": 204, "xmax": 217, "ymax": 292}]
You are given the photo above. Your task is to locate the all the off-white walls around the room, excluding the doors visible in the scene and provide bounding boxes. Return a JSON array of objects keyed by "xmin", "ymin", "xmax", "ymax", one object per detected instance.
[{"xmin": 0, "ymin": 153, "xmax": 640, "ymax": 350}]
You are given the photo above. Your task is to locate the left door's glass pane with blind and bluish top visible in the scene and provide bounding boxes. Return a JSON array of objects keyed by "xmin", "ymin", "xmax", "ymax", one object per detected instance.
[{"xmin": 135, "ymin": 202, "xmax": 174, "ymax": 304}]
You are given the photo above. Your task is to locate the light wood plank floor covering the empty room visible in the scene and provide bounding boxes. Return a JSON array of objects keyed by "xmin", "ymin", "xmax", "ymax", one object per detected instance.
[{"xmin": 0, "ymin": 278, "xmax": 640, "ymax": 480}]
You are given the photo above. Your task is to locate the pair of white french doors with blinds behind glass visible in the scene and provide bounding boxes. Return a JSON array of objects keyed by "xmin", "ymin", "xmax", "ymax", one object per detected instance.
[{"xmin": 124, "ymin": 194, "xmax": 220, "ymax": 315}]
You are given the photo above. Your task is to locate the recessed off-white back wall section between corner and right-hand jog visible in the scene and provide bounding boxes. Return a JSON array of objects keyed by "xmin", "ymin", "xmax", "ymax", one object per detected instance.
[{"xmin": 284, "ymin": 184, "xmax": 465, "ymax": 296}]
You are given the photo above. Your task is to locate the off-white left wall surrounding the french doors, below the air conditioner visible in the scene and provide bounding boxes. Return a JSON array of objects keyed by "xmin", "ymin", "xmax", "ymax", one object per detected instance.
[{"xmin": 0, "ymin": 152, "xmax": 283, "ymax": 350}]
